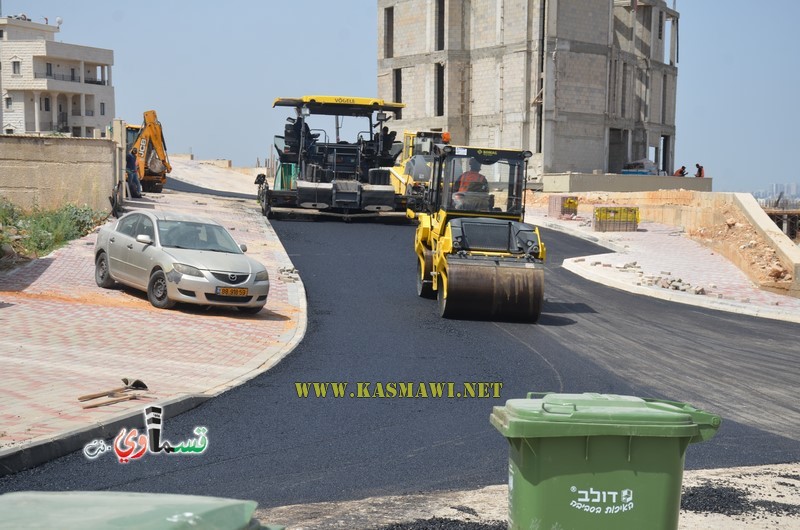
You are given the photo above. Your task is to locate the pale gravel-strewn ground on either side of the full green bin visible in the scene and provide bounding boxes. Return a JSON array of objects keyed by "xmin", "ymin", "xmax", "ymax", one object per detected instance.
[{"xmin": 257, "ymin": 463, "xmax": 800, "ymax": 530}]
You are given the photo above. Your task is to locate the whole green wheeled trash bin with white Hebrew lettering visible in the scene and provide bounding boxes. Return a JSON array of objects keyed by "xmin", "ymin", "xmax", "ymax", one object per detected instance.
[{"xmin": 490, "ymin": 392, "xmax": 721, "ymax": 530}]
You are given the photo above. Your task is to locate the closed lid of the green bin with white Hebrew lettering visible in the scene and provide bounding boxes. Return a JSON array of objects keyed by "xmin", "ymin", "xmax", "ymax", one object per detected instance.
[{"xmin": 490, "ymin": 392, "xmax": 721, "ymax": 442}]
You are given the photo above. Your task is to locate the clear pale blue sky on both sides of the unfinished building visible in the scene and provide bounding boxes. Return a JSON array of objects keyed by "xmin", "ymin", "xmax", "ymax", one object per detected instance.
[{"xmin": 6, "ymin": 0, "xmax": 800, "ymax": 191}]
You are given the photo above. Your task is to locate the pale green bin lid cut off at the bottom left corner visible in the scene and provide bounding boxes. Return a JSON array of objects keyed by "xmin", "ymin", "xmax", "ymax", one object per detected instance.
[{"xmin": 0, "ymin": 491, "xmax": 258, "ymax": 530}]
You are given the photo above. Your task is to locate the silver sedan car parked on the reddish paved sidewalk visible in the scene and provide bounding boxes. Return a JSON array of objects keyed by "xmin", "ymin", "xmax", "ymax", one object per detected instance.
[{"xmin": 94, "ymin": 211, "xmax": 269, "ymax": 313}]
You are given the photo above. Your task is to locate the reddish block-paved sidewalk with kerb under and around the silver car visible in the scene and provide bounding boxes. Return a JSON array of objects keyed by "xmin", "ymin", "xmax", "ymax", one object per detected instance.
[{"xmin": 0, "ymin": 163, "xmax": 306, "ymax": 475}]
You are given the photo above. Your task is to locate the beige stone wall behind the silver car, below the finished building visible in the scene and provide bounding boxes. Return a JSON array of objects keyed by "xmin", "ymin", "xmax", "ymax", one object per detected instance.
[{"xmin": 0, "ymin": 135, "xmax": 116, "ymax": 212}]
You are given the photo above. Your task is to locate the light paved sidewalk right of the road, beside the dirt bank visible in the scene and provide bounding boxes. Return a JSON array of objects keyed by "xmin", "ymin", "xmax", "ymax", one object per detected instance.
[{"xmin": 525, "ymin": 208, "xmax": 800, "ymax": 322}]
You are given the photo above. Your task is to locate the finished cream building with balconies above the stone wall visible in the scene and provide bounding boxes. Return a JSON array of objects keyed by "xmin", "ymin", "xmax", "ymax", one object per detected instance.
[{"xmin": 0, "ymin": 15, "xmax": 115, "ymax": 137}]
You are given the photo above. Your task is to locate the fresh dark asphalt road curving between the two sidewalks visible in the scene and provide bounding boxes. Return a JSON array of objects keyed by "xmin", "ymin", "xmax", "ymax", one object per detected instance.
[{"xmin": 0, "ymin": 197, "xmax": 800, "ymax": 507}]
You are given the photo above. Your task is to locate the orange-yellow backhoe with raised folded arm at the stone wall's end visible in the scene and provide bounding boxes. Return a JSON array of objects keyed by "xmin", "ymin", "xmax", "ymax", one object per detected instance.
[{"xmin": 126, "ymin": 110, "xmax": 172, "ymax": 193}]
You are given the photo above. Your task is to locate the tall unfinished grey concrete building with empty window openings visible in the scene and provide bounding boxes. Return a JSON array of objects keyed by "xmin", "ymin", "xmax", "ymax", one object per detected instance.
[{"xmin": 378, "ymin": 0, "xmax": 678, "ymax": 180}]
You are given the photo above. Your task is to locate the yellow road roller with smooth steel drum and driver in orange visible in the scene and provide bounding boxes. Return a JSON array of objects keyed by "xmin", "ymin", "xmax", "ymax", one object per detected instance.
[{"xmin": 407, "ymin": 144, "xmax": 546, "ymax": 322}]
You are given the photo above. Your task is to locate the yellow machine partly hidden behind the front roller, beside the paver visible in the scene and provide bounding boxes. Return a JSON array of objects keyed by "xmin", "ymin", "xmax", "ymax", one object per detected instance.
[{"xmin": 389, "ymin": 129, "xmax": 450, "ymax": 211}]
